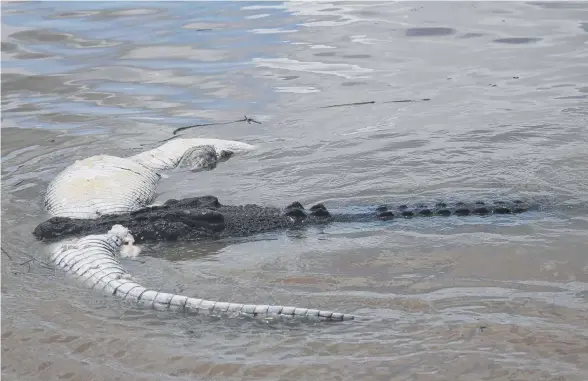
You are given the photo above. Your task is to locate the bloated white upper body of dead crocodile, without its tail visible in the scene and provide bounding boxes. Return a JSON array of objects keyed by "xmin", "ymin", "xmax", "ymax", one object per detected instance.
[{"xmin": 45, "ymin": 139, "xmax": 253, "ymax": 218}]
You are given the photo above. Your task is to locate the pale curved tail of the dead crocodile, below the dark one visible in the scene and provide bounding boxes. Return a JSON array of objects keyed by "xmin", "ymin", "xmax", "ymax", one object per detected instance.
[{"xmin": 51, "ymin": 225, "xmax": 354, "ymax": 321}]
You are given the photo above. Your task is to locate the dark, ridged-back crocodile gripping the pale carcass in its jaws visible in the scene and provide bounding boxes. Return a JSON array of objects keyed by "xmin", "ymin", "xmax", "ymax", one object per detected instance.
[{"xmin": 33, "ymin": 196, "xmax": 529, "ymax": 243}]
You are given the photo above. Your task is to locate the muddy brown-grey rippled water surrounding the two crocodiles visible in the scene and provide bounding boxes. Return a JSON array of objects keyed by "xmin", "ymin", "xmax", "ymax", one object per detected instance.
[{"xmin": 1, "ymin": 2, "xmax": 588, "ymax": 381}]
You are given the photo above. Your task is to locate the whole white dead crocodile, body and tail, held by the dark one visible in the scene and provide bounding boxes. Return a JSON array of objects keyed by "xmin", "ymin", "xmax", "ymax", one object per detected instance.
[{"xmin": 45, "ymin": 139, "xmax": 353, "ymax": 320}]
